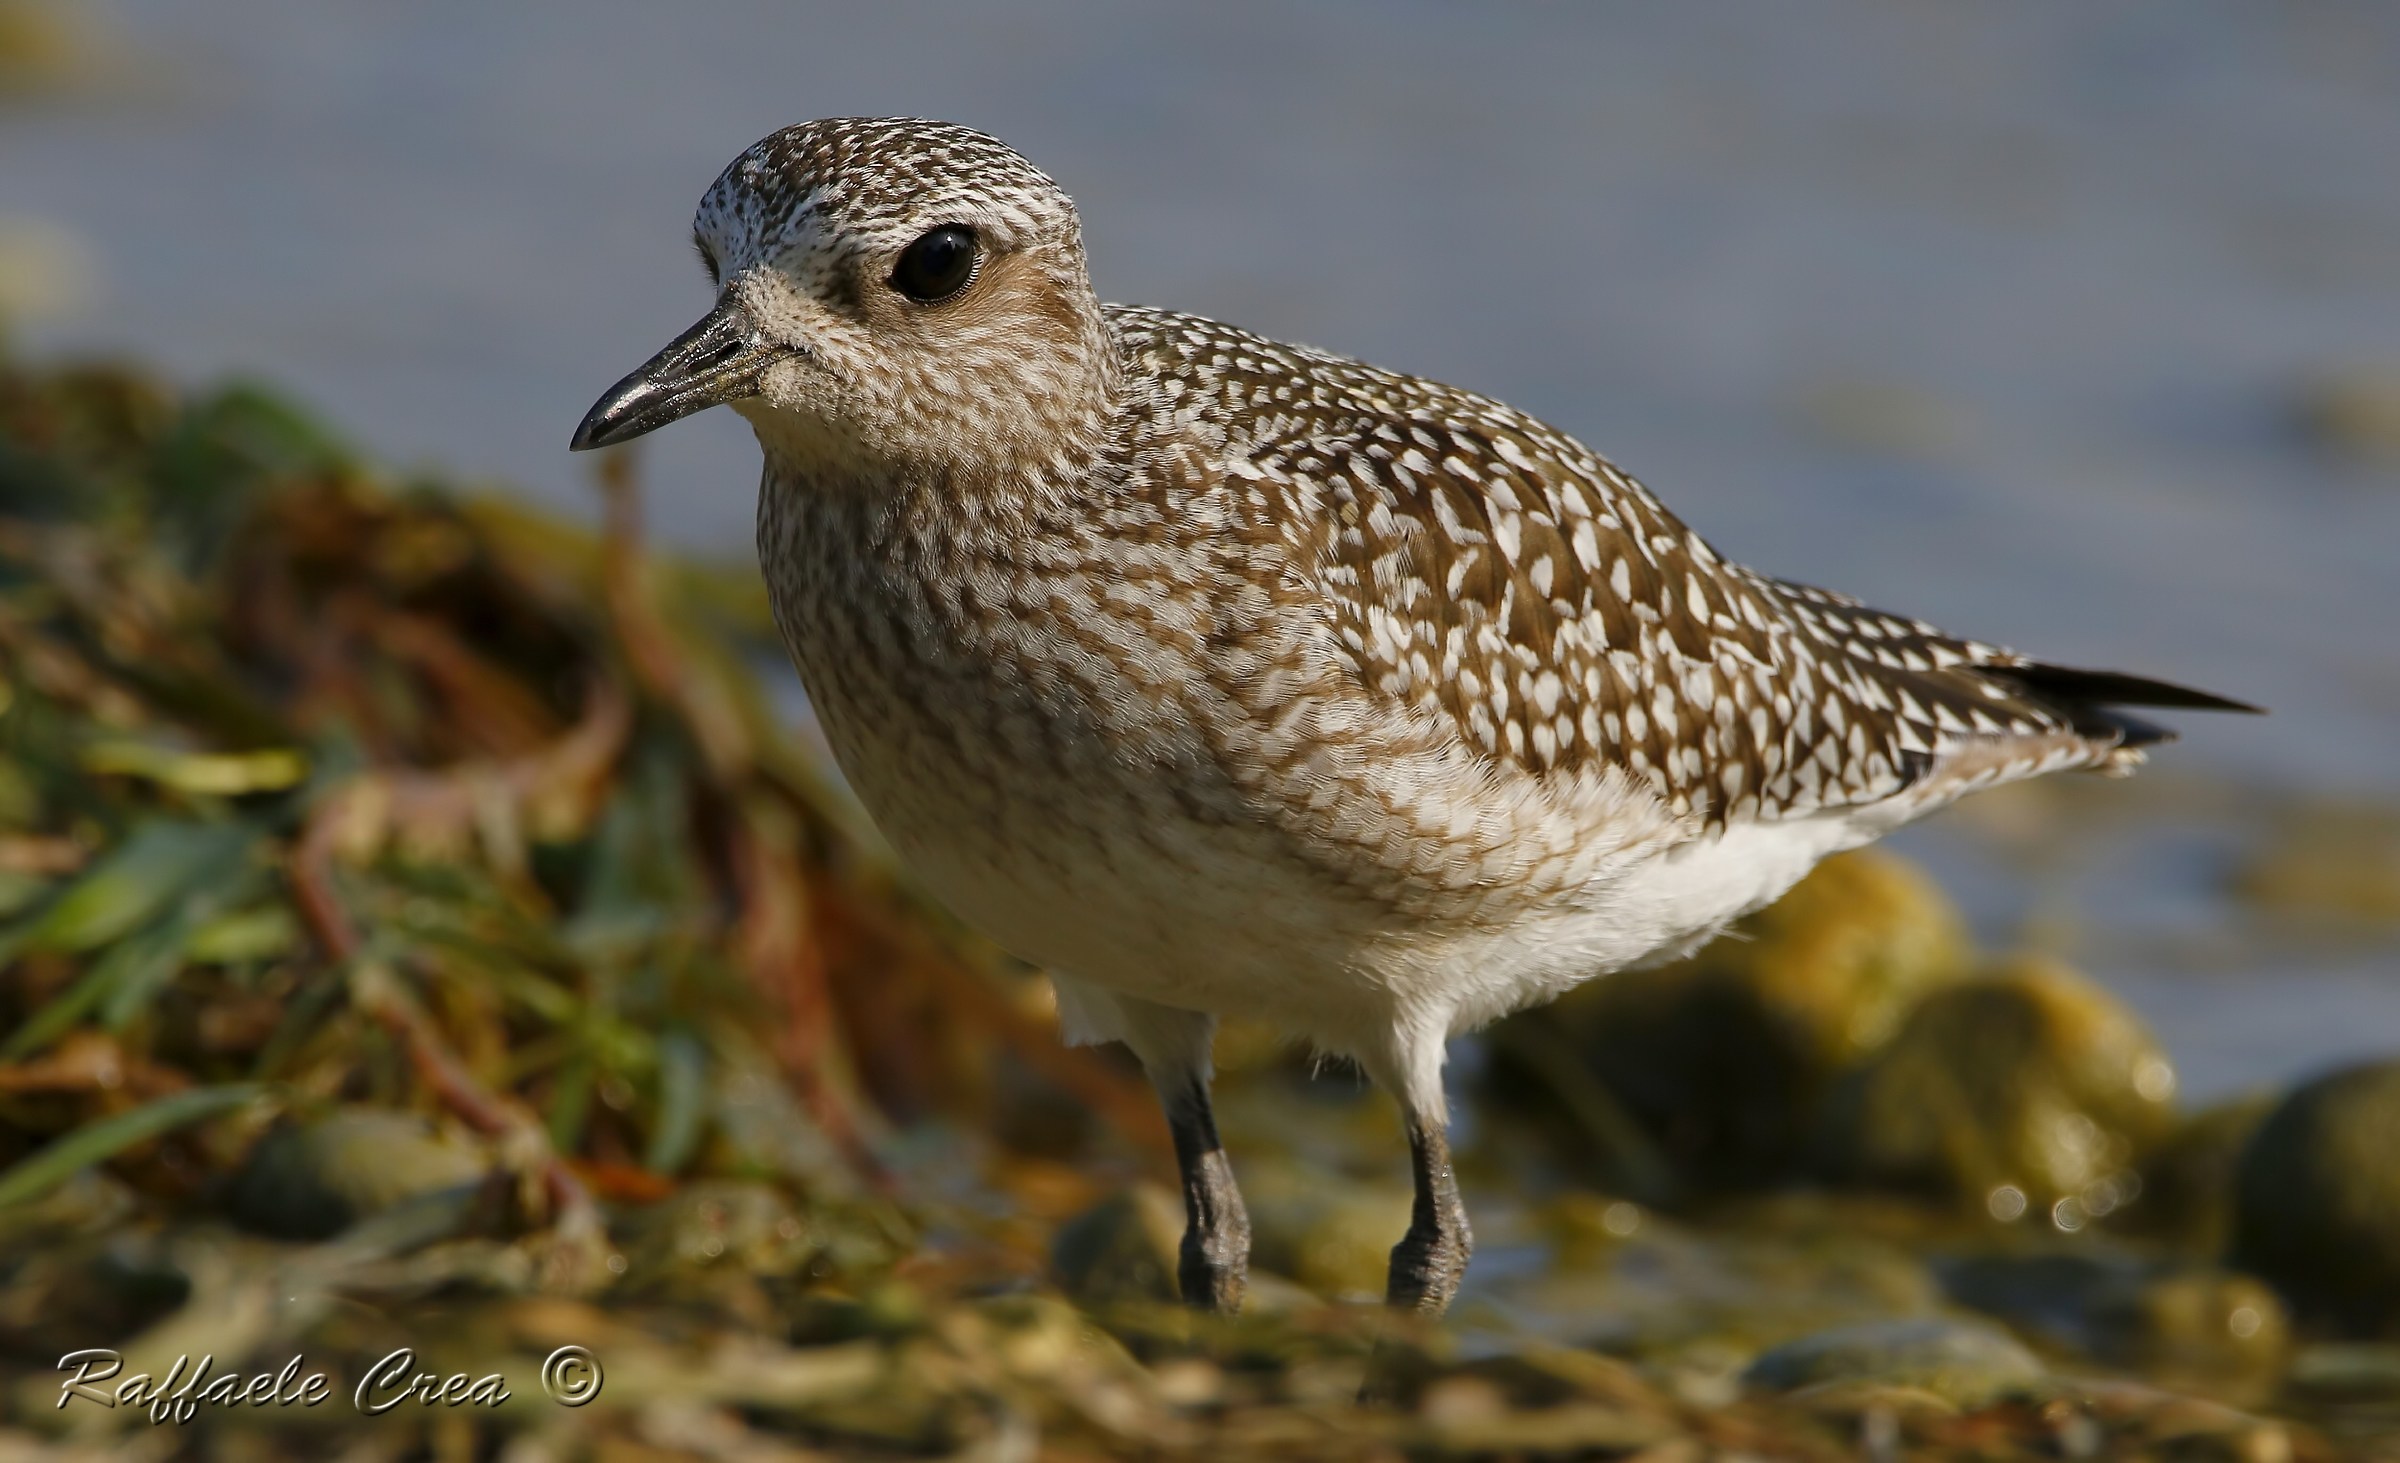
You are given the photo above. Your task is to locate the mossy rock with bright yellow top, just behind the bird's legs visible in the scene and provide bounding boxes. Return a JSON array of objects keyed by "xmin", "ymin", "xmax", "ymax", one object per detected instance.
[{"xmin": 1490, "ymin": 851, "xmax": 1968, "ymax": 1184}]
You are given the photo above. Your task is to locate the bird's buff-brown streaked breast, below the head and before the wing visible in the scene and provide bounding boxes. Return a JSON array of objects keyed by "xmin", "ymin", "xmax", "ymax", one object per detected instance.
[{"xmin": 758, "ymin": 479, "xmax": 1324, "ymax": 979}]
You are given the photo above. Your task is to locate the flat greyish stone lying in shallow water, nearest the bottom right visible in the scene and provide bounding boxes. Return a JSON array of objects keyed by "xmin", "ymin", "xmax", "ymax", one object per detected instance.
[{"xmin": 1742, "ymin": 1317, "xmax": 2042, "ymax": 1408}]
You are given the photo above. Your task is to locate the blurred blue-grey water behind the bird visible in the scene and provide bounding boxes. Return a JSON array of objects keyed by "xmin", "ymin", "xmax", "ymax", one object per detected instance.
[{"xmin": 0, "ymin": 0, "xmax": 2400, "ymax": 1096}]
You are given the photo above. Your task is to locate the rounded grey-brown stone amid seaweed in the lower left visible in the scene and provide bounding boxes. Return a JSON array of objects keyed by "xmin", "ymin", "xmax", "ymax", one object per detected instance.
[{"xmin": 226, "ymin": 1108, "xmax": 492, "ymax": 1240}]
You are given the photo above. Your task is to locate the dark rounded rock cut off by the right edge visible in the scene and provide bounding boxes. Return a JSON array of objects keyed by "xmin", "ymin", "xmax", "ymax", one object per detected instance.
[{"xmin": 2232, "ymin": 1060, "xmax": 2400, "ymax": 1336}]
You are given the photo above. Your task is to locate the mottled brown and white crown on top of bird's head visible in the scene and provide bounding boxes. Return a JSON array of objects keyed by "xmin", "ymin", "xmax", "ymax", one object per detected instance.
[{"xmin": 694, "ymin": 118, "xmax": 1078, "ymax": 273}]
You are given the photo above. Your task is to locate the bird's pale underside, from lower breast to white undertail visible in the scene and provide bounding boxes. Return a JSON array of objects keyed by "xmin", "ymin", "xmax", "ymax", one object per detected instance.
[{"xmin": 806, "ymin": 647, "xmax": 1862, "ymax": 1050}]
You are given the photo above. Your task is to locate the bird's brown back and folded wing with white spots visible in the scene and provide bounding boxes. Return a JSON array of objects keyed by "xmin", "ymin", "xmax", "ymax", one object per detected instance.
[{"xmin": 1111, "ymin": 309, "xmax": 2160, "ymax": 825}]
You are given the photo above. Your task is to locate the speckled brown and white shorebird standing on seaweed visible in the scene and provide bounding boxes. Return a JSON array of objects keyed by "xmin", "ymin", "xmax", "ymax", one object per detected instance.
[{"xmin": 571, "ymin": 118, "xmax": 2251, "ymax": 1314}]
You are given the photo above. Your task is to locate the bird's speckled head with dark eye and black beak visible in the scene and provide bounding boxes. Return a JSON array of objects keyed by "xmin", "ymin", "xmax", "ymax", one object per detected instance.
[{"xmin": 571, "ymin": 118, "xmax": 1114, "ymax": 472}]
